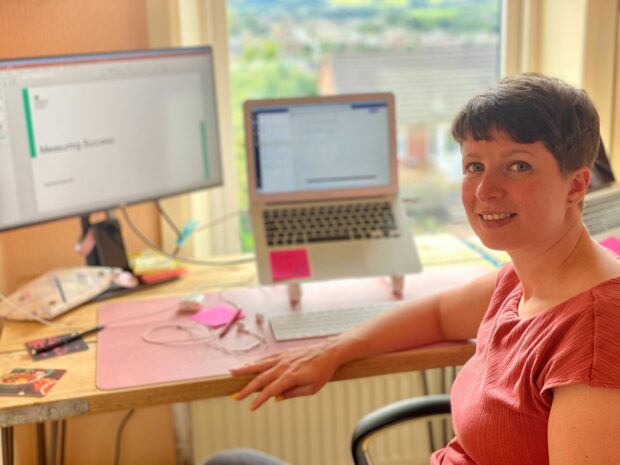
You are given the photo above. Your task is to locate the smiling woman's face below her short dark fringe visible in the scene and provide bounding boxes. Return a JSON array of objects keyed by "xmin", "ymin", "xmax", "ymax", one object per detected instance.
[{"xmin": 461, "ymin": 131, "xmax": 587, "ymax": 252}]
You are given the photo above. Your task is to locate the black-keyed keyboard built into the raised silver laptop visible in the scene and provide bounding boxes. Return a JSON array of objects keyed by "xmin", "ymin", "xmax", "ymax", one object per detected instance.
[{"xmin": 263, "ymin": 202, "xmax": 399, "ymax": 246}]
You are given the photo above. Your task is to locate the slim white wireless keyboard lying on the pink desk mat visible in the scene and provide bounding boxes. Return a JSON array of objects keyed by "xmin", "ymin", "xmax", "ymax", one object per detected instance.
[{"xmin": 269, "ymin": 302, "xmax": 402, "ymax": 342}]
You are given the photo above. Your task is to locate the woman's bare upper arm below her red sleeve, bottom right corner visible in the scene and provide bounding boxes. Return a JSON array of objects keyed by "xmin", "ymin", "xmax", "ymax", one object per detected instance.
[{"xmin": 548, "ymin": 384, "xmax": 620, "ymax": 465}]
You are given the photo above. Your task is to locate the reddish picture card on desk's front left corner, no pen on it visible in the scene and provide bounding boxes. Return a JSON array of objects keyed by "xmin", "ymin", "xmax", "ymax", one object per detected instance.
[{"xmin": 0, "ymin": 368, "xmax": 66, "ymax": 397}]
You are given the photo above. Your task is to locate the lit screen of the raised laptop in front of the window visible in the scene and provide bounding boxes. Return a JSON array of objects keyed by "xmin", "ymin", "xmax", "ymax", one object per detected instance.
[{"xmin": 246, "ymin": 96, "xmax": 393, "ymax": 195}]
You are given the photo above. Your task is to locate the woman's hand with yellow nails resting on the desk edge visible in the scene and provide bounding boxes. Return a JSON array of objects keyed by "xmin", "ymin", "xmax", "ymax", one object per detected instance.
[{"xmin": 231, "ymin": 340, "xmax": 341, "ymax": 410}]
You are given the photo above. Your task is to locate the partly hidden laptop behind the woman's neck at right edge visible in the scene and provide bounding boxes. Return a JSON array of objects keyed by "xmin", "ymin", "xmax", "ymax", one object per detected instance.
[{"xmin": 583, "ymin": 141, "xmax": 620, "ymax": 241}]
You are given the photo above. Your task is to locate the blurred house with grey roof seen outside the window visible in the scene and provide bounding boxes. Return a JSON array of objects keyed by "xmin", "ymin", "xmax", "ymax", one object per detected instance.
[{"xmin": 319, "ymin": 39, "xmax": 499, "ymax": 176}]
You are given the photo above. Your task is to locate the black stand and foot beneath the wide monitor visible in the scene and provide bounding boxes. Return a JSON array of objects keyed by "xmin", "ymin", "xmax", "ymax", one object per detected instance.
[{"xmin": 80, "ymin": 210, "xmax": 178, "ymax": 301}]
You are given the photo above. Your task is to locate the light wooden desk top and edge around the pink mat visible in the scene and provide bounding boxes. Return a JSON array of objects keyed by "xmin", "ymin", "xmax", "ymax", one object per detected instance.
[{"xmin": 0, "ymin": 264, "xmax": 484, "ymax": 465}]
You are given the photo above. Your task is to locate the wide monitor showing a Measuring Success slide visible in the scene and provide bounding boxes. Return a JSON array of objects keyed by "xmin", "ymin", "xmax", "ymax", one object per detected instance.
[{"xmin": 0, "ymin": 47, "xmax": 222, "ymax": 230}]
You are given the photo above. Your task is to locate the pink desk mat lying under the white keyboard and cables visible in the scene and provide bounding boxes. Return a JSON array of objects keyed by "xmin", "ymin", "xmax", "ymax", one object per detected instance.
[{"xmin": 96, "ymin": 265, "xmax": 489, "ymax": 389}]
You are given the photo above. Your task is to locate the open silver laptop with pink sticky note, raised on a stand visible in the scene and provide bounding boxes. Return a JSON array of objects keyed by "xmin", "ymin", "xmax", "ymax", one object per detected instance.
[{"xmin": 244, "ymin": 93, "xmax": 421, "ymax": 284}]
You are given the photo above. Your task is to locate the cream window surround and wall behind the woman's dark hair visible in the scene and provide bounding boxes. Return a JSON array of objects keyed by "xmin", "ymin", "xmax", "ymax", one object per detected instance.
[{"xmin": 504, "ymin": 0, "xmax": 620, "ymax": 161}]
